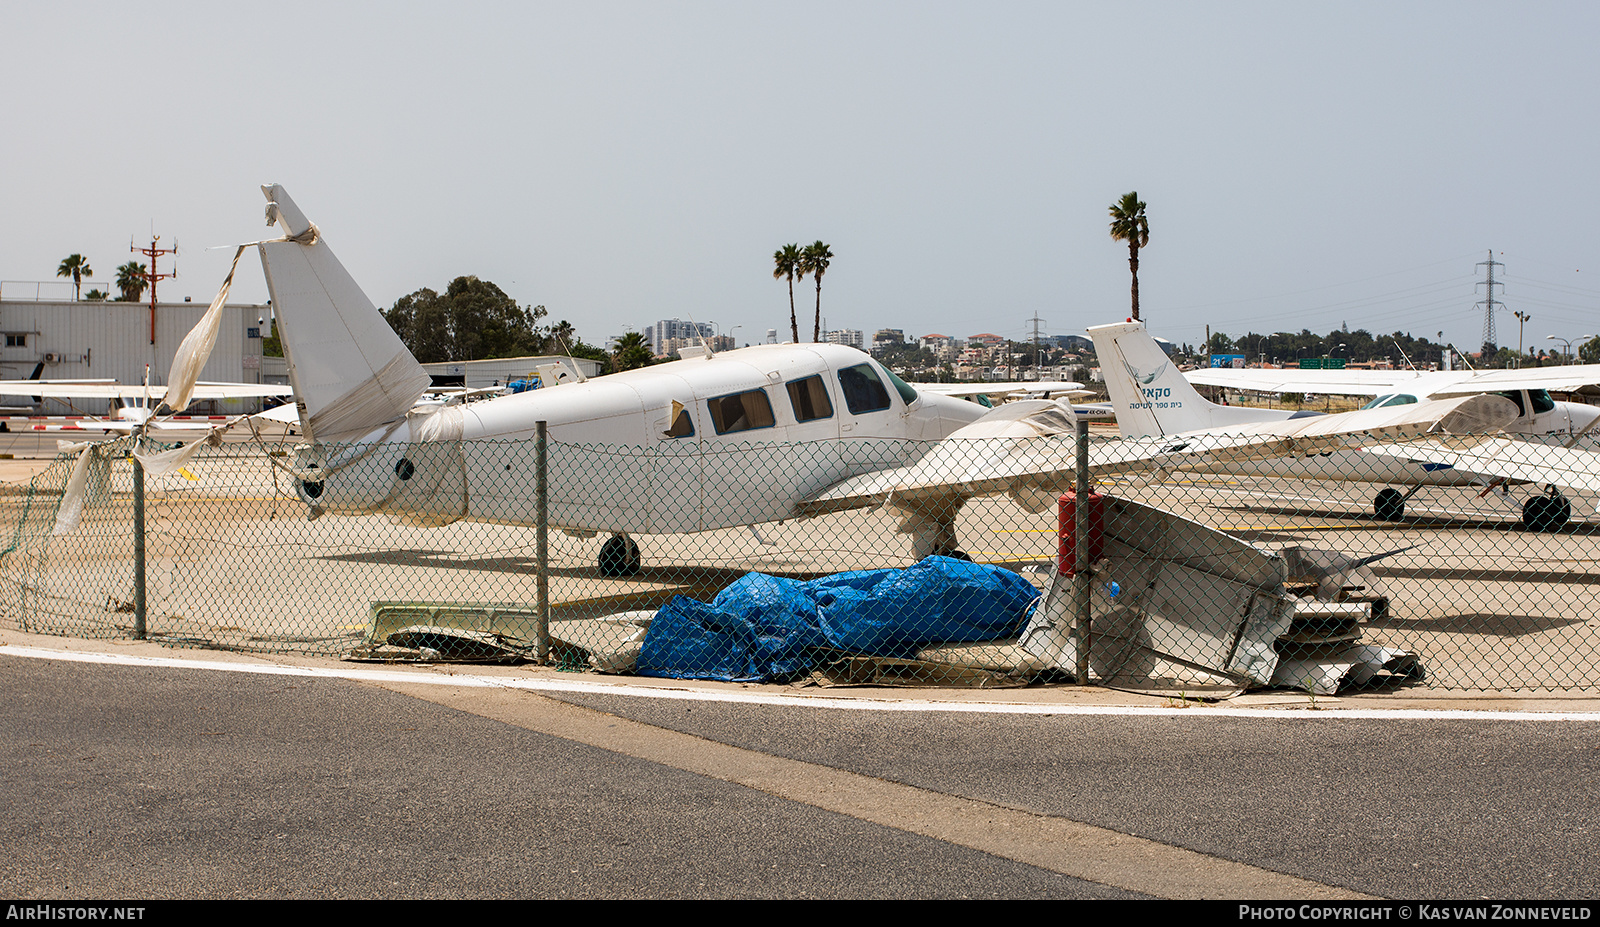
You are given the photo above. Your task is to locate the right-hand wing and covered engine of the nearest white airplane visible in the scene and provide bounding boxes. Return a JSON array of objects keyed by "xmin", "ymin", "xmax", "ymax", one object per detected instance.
[{"xmin": 795, "ymin": 395, "xmax": 1517, "ymax": 516}]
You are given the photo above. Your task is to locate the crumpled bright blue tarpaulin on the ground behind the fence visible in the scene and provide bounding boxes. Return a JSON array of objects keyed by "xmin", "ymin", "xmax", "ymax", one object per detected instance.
[{"xmin": 637, "ymin": 557, "xmax": 1038, "ymax": 682}]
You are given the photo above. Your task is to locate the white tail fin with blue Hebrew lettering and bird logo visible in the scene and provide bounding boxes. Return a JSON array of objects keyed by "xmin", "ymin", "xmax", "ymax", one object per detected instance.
[{"xmin": 1090, "ymin": 322, "xmax": 1290, "ymax": 437}]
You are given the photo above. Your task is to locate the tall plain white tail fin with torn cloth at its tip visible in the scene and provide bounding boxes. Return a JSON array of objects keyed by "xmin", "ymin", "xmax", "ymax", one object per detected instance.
[{"xmin": 256, "ymin": 184, "xmax": 432, "ymax": 442}]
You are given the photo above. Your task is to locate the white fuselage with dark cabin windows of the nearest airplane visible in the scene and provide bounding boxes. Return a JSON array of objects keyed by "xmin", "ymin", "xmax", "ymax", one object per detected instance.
[{"xmin": 299, "ymin": 344, "xmax": 986, "ymax": 533}]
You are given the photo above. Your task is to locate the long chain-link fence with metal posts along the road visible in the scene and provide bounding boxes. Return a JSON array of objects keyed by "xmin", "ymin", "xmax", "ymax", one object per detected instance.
[{"xmin": 0, "ymin": 439, "xmax": 1600, "ymax": 693}]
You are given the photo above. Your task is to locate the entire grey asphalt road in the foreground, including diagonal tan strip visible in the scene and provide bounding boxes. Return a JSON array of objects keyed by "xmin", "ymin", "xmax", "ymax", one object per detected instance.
[{"xmin": 0, "ymin": 634, "xmax": 1600, "ymax": 898}]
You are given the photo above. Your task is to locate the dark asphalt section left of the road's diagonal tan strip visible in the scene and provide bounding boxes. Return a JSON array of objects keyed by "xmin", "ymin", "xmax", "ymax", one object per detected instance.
[{"xmin": 0, "ymin": 658, "xmax": 1133, "ymax": 898}]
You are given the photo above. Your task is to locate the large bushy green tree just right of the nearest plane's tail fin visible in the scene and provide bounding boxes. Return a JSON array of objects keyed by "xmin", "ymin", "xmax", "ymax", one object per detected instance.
[{"xmin": 384, "ymin": 277, "xmax": 549, "ymax": 363}]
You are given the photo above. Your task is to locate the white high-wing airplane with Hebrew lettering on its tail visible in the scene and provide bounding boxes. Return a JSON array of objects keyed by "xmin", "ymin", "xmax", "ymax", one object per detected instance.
[{"xmin": 1090, "ymin": 322, "xmax": 1600, "ymax": 530}]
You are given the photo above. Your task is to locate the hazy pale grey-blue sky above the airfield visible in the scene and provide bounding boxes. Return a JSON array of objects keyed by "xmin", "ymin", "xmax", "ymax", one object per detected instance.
[{"xmin": 0, "ymin": 0, "xmax": 1600, "ymax": 351}]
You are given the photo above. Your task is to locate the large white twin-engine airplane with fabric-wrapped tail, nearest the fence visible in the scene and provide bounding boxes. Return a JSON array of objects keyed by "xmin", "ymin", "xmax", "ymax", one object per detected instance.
[{"xmin": 246, "ymin": 186, "xmax": 1512, "ymax": 575}]
